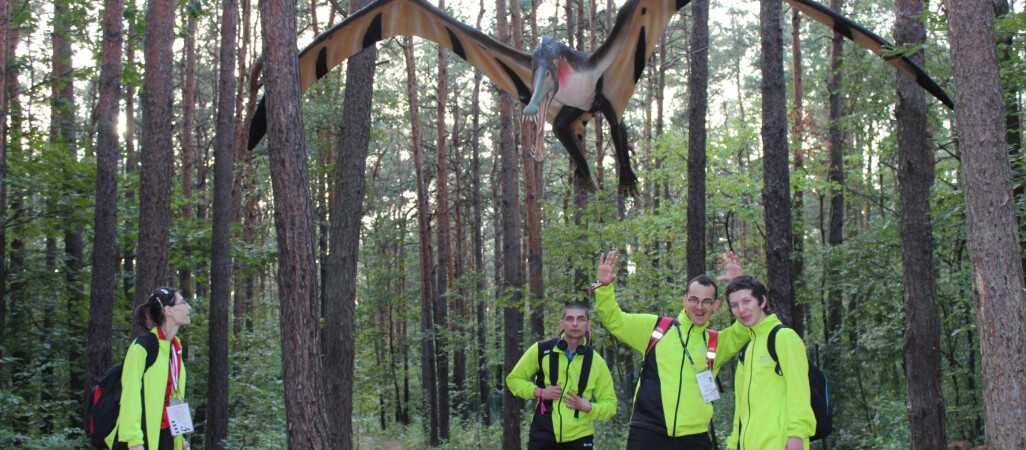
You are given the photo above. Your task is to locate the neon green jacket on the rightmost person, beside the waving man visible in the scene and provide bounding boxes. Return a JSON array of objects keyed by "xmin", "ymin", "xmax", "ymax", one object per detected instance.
[{"xmin": 726, "ymin": 315, "xmax": 816, "ymax": 450}]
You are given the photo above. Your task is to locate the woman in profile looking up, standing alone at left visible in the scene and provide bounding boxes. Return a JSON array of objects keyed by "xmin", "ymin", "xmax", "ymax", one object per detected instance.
[{"xmin": 107, "ymin": 288, "xmax": 192, "ymax": 450}]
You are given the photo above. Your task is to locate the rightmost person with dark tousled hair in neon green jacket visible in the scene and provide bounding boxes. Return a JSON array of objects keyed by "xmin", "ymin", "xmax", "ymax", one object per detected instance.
[{"xmin": 726, "ymin": 276, "xmax": 816, "ymax": 450}]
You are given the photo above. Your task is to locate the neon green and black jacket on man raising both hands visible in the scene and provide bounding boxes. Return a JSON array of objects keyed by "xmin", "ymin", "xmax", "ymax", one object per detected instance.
[{"xmin": 595, "ymin": 285, "xmax": 748, "ymax": 437}]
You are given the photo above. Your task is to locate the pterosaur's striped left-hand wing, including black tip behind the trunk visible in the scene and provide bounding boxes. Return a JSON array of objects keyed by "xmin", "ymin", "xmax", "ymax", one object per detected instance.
[{"xmin": 249, "ymin": 0, "xmax": 531, "ymax": 149}]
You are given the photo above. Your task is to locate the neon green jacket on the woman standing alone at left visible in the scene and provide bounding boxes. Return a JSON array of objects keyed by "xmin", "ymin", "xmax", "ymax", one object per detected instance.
[{"xmin": 107, "ymin": 328, "xmax": 187, "ymax": 450}]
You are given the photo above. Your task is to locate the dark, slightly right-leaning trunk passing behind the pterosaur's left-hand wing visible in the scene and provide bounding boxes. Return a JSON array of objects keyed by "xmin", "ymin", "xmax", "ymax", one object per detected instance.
[{"xmin": 323, "ymin": 0, "xmax": 378, "ymax": 444}]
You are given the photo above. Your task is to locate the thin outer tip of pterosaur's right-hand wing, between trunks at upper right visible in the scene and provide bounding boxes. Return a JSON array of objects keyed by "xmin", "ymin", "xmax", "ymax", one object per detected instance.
[{"xmin": 784, "ymin": 0, "xmax": 955, "ymax": 109}]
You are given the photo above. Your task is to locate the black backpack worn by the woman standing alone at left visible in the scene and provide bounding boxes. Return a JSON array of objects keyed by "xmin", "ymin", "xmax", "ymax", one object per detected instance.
[{"xmin": 84, "ymin": 332, "xmax": 159, "ymax": 448}]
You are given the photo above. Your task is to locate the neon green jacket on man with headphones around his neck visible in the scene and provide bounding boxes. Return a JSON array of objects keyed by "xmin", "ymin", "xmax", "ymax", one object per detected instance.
[{"xmin": 506, "ymin": 342, "xmax": 617, "ymax": 443}]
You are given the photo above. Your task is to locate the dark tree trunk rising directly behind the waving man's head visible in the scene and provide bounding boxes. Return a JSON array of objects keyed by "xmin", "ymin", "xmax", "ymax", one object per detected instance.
[{"xmin": 686, "ymin": 0, "xmax": 709, "ymax": 280}]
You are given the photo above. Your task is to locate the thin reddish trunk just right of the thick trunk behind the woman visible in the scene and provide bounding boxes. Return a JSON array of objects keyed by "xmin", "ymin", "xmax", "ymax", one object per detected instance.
[{"xmin": 177, "ymin": 11, "xmax": 197, "ymax": 298}]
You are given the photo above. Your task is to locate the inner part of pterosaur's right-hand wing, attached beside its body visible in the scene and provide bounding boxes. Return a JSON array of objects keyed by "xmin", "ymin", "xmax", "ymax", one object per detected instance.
[{"xmin": 590, "ymin": 0, "xmax": 689, "ymax": 121}]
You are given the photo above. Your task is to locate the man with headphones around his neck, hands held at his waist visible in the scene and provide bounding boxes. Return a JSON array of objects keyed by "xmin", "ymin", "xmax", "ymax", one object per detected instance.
[{"xmin": 506, "ymin": 303, "xmax": 617, "ymax": 450}]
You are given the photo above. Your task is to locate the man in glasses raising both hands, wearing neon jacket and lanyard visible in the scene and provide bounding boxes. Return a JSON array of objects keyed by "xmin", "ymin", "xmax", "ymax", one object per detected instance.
[{"xmin": 594, "ymin": 251, "xmax": 748, "ymax": 450}]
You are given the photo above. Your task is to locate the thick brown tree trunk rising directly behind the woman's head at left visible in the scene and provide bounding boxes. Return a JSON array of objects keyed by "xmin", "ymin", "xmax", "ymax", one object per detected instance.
[{"xmin": 132, "ymin": 0, "xmax": 174, "ymax": 319}]
